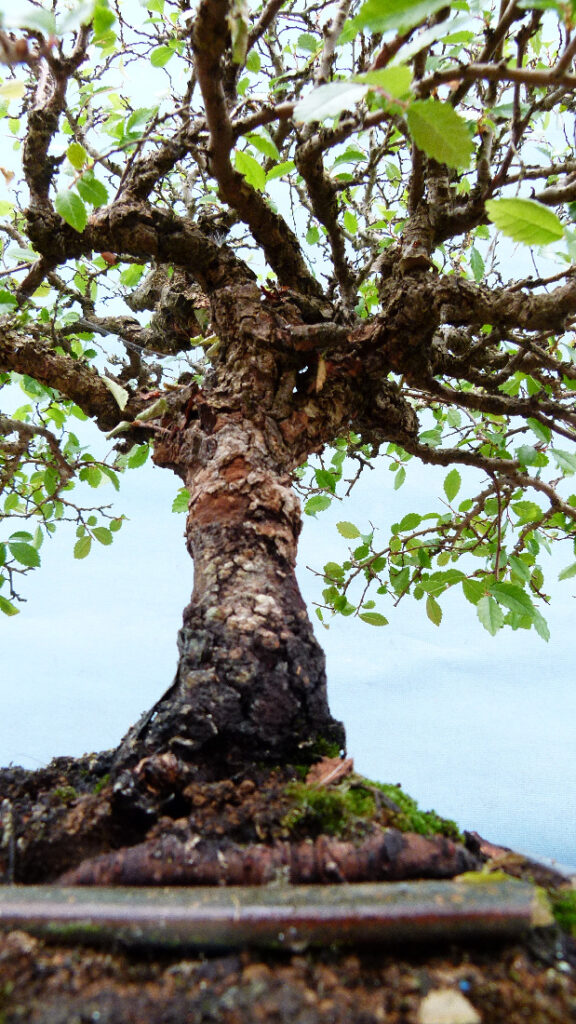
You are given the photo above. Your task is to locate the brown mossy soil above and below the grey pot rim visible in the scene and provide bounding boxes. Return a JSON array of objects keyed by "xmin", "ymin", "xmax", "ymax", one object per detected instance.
[{"xmin": 0, "ymin": 754, "xmax": 576, "ymax": 1024}]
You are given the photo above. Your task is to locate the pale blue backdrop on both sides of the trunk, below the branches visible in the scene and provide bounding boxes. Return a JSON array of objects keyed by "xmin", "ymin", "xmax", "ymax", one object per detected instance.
[{"xmin": 0, "ymin": 0, "xmax": 576, "ymax": 869}]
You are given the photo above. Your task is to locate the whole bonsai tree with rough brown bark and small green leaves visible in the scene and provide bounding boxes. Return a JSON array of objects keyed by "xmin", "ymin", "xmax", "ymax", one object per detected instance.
[{"xmin": 0, "ymin": 0, "xmax": 576, "ymax": 767}]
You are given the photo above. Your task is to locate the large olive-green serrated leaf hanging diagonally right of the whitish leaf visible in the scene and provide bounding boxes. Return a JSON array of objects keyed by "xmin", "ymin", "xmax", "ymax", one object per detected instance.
[{"xmin": 406, "ymin": 99, "xmax": 474, "ymax": 169}]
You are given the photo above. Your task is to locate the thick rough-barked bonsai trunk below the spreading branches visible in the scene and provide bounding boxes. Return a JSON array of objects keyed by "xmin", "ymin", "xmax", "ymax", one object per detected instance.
[{"xmin": 114, "ymin": 399, "xmax": 344, "ymax": 773}]
